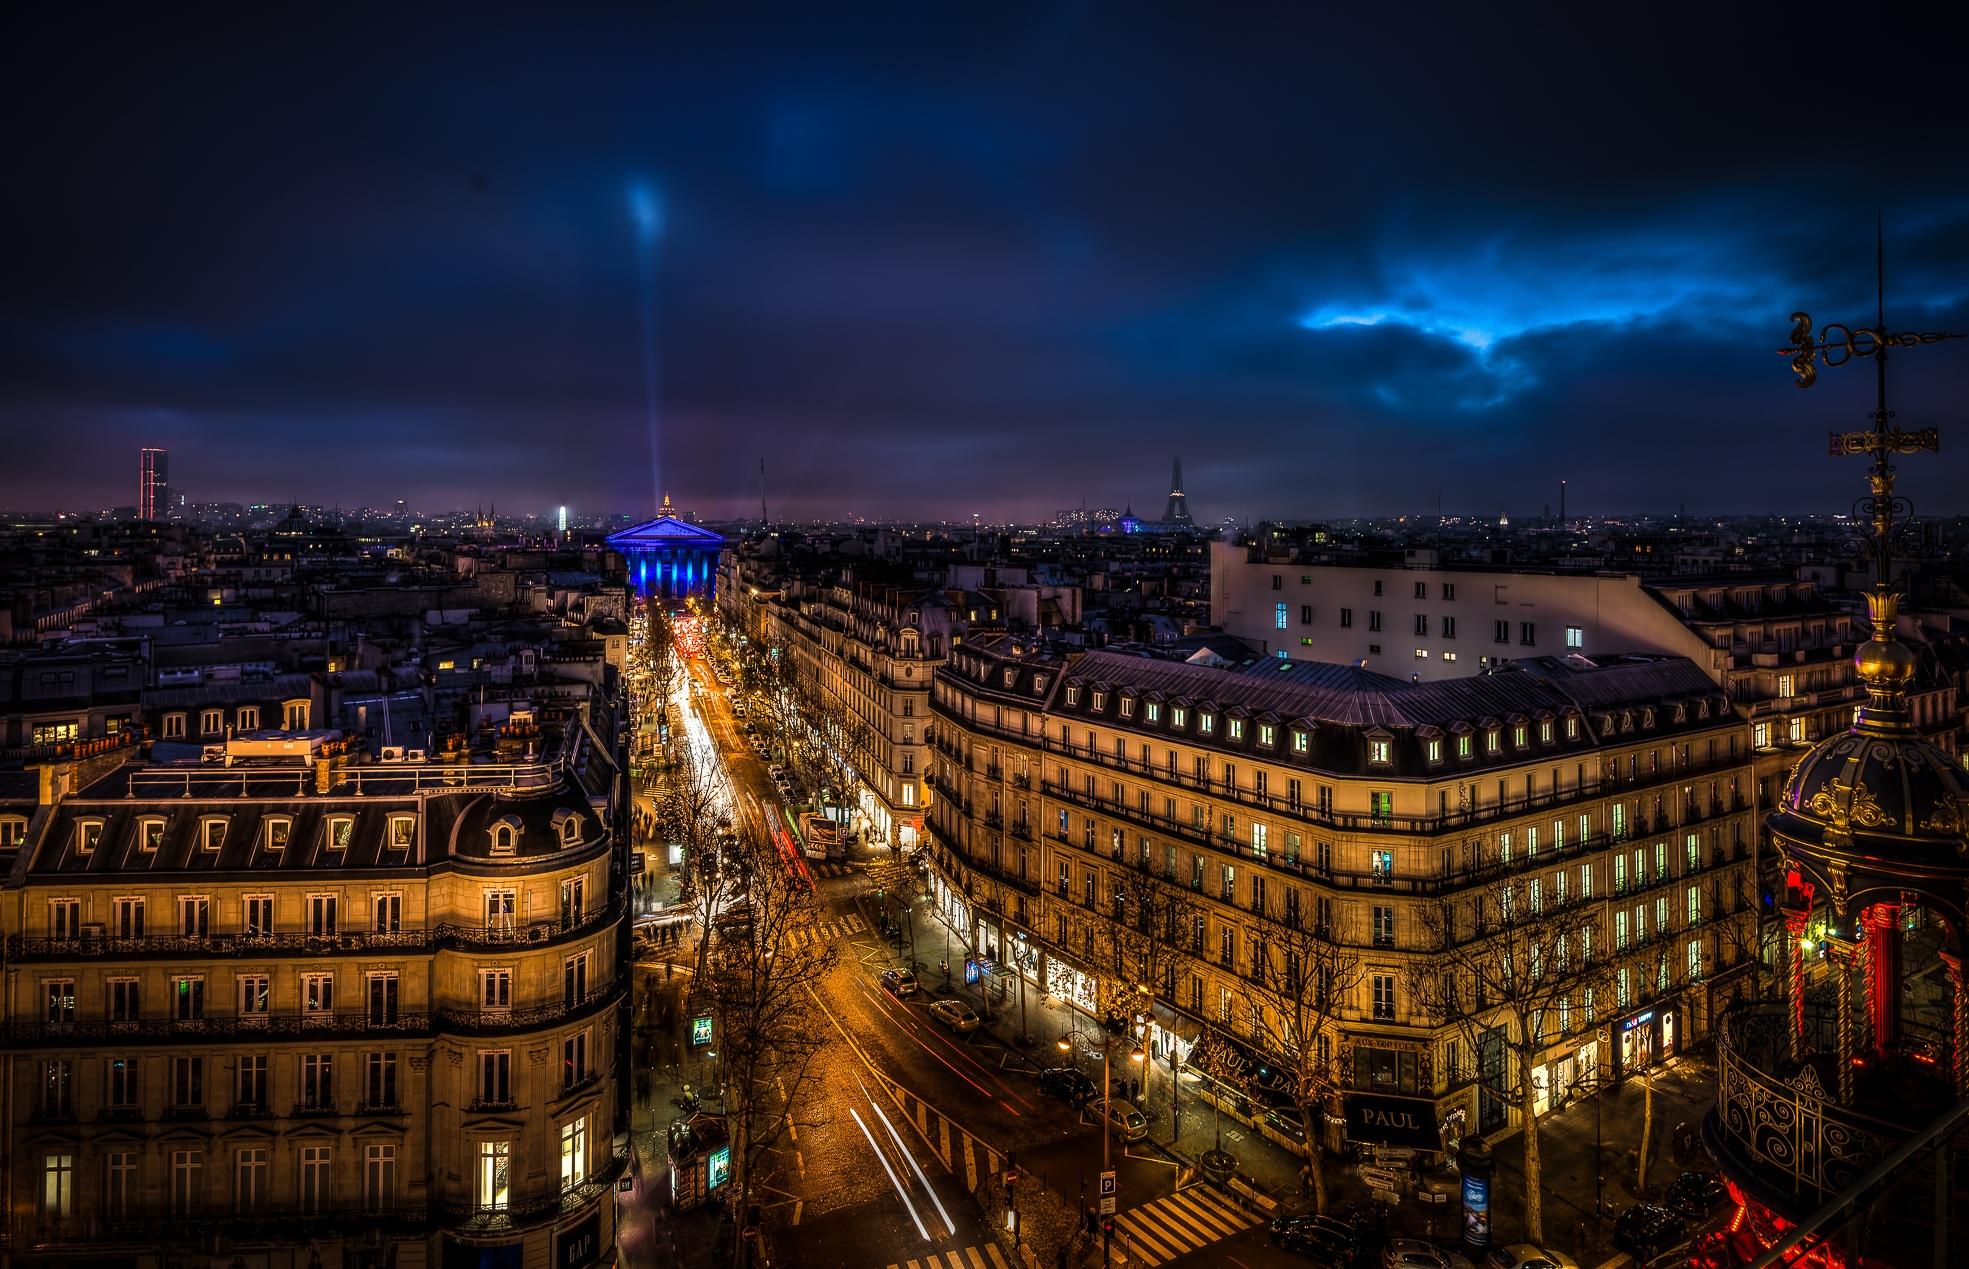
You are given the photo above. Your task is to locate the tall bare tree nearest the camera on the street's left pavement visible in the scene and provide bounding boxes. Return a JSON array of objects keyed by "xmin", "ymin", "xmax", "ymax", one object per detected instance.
[{"xmin": 699, "ymin": 827, "xmax": 837, "ymax": 1251}]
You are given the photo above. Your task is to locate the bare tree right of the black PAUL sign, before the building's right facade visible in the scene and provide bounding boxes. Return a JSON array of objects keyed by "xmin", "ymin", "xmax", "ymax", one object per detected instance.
[{"xmin": 1408, "ymin": 873, "xmax": 1609, "ymax": 1243}]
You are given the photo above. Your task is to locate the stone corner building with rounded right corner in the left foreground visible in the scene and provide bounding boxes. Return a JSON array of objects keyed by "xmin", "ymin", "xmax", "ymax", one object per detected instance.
[{"xmin": 0, "ymin": 721, "xmax": 628, "ymax": 1269}]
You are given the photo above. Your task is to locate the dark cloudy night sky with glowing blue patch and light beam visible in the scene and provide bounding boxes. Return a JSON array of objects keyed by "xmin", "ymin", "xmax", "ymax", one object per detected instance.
[{"xmin": 0, "ymin": 4, "xmax": 1969, "ymax": 520}]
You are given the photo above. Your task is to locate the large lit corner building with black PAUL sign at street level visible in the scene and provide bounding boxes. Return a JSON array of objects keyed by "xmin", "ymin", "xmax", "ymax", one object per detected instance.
[{"xmin": 929, "ymin": 640, "xmax": 1754, "ymax": 1149}]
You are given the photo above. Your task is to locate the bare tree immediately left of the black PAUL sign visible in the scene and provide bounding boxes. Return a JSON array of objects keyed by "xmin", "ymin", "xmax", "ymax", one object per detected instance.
[{"xmin": 1244, "ymin": 893, "xmax": 1366, "ymax": 1212}]
